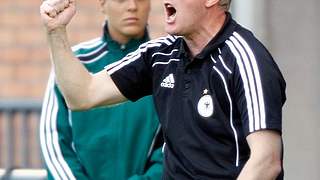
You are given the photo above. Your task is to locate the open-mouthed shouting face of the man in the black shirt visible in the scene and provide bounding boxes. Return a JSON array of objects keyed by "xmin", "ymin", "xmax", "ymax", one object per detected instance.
[{"xmin": 164, "ymin": 0, "xmax": 205, "ymax": 35}]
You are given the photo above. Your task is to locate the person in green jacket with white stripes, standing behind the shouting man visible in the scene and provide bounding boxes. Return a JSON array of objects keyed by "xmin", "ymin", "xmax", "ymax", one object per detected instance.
[{"xmin": 40, "ymin": 0, "xmax": 162, "ymax": 180}]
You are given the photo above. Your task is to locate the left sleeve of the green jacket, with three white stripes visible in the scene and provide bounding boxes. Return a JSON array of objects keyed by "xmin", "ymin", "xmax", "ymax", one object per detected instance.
[{"xmin": 40, "ymin": 72, "xmax": 88, "ymax": 179}]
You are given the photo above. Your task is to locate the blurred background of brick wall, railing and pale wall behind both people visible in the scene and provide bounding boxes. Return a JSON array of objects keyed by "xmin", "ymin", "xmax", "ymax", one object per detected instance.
[{"xmin": 0, "ymin": 0, "xmax": 320, "ymax": 180}]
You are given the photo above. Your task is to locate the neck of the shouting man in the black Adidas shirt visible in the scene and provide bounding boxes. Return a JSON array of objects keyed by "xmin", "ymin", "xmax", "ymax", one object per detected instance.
[{"xmin": 184, "ymin": 13, "xmax": 226, "ymax": 57}]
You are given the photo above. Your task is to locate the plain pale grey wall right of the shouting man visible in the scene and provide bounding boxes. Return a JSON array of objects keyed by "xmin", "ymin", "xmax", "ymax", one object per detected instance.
[{"xmin": 232, "ymin": 0, "xmax": 320, "ymax": 180}]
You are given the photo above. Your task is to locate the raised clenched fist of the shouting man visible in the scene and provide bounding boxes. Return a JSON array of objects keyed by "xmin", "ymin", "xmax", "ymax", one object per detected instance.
[{"xmin": 40, "ymin": 0, "xmax": 76, "ymax": 32}]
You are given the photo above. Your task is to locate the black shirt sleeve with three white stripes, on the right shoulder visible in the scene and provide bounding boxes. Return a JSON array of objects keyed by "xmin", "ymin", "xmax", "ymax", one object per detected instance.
[{"xmin": 227, "ymin": 33, "xmax": 286, "ymax": 136}]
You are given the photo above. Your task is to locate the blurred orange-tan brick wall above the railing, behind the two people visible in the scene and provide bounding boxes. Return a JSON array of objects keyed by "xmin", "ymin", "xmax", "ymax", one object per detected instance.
[{"xmin": 0, "ymin": 0, "xmax": 164, "ymax": 99}]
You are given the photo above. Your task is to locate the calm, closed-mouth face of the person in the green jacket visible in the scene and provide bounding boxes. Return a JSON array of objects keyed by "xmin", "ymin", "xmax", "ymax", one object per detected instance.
[{"xmin": 100, "ymin": 0, "xmax": 150, "ymax": 37}]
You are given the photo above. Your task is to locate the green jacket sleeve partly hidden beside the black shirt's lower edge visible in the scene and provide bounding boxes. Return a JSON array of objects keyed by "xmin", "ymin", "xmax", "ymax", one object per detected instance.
[{"xmin": 128, "ymin": 126, "xmax": 164, "ymax": 180}]
